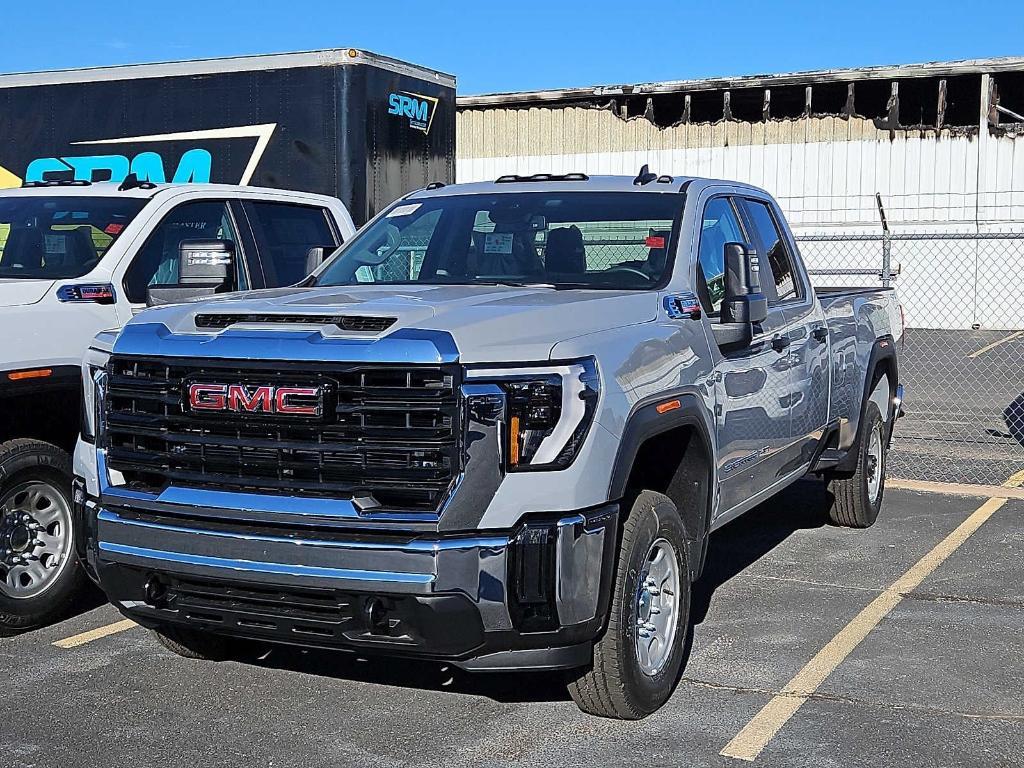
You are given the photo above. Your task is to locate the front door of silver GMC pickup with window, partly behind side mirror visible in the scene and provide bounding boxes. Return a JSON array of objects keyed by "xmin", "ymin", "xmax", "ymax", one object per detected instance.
[{"xmin": 697, "ymin": 197, "xmax": 793, "ymax": 513}]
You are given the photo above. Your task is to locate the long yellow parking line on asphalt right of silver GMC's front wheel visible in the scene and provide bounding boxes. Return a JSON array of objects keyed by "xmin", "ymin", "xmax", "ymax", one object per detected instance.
[{"xmin": 720, "ymin": 499, "xmax": 1007, "ymax": 760}]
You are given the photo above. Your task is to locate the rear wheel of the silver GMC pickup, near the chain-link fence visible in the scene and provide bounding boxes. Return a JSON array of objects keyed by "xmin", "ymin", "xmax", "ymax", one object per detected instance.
[{"xmin": 825, "ymin": 401, "xmax": 889, "ymax": 528}]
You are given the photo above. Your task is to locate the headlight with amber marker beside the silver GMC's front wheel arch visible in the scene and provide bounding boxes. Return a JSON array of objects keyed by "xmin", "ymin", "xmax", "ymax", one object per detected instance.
[{"xmin": 467, "ymin": 357, "xmax": 600, "ymax": 472}]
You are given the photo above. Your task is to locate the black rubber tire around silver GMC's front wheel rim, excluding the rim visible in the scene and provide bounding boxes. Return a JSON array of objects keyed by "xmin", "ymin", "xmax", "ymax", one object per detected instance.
[{"xmin": 568, "ymin": 490, "xmax": 690, "ymax": 720}]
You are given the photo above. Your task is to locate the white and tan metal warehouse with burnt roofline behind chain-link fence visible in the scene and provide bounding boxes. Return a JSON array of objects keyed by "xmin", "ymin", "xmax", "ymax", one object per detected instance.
[{"xmin": 456, "ymin": 58, "xmax": 1024, "ymax": 330}]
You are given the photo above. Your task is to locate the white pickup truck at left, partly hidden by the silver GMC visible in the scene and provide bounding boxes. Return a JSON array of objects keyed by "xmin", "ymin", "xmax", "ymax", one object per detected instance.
[{"xmin": 0, "ymin": 177, "xmax": 355, "ymax": 635}]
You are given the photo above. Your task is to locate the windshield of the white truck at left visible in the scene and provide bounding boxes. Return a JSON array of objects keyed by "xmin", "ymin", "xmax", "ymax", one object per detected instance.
[{"xmin": 0, "ymin": 196, "xmax": 146, "ymax": 280}]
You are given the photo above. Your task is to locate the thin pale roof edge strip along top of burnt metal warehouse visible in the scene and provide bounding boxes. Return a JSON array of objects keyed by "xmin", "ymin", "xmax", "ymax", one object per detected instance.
[{"xmin": 457, "ymin": 56, "xmax": 1024, "ymax": 109}]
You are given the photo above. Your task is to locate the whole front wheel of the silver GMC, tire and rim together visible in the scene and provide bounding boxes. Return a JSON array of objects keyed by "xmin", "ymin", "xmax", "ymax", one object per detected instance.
[{"xmin": 568, "ymin": 490, "xmax": 690, "ymax": 720}]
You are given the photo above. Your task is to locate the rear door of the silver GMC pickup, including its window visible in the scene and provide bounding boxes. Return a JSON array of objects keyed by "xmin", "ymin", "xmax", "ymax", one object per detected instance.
[{"xmin": 742, "ymin": 198, "xmax": 830, "ymax": 471}]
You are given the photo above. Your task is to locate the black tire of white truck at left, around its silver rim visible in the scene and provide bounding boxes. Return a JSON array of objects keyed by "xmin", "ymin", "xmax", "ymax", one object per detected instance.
[{"xmin": 0, "ymin": 438, "xmax": 89, "ymax": 637}]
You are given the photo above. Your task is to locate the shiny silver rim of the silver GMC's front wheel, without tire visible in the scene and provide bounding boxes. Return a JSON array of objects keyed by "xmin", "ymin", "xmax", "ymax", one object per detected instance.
[{"xmin": 636, "ymin": 539, "xmax": 679, "ymax": 677}]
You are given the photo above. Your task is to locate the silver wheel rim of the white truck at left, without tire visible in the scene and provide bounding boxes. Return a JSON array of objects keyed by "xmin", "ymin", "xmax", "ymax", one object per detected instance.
[{"xmin": 0, "ymin": 480, "xmax": 72, "ymax": 599}]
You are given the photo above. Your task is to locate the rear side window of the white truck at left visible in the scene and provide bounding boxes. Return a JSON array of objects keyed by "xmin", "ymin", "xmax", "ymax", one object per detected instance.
[{"xmin": 242, "ymin": 201, "xmax": 341, "ymax": 288}]
